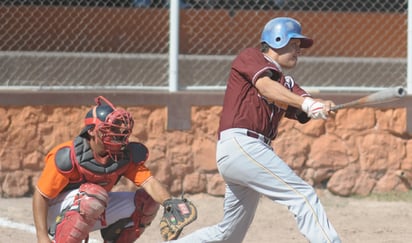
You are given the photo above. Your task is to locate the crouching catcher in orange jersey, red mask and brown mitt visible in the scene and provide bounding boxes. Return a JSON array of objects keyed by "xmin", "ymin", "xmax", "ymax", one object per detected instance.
[{"xmin": 33, "ymin": 96, "xmax": 197, "ymax": 243}]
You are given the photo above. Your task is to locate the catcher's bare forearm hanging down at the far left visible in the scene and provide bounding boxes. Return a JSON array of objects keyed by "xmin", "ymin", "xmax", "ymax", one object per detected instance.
[{"xmin": 32, "ymin": 188, "xmax": 51, "ymax": 243}]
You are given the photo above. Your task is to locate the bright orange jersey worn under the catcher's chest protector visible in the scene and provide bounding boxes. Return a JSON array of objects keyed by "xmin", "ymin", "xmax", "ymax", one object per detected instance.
[{"xmin": 37, "ymin": 137, "xmax": 152, "ymax": 199}]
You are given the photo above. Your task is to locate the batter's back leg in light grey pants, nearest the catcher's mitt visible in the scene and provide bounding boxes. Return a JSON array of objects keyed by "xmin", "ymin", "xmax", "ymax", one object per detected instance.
[{"xmin": 171, "ymin": 135, "xmax": 268, "ymax": 243}]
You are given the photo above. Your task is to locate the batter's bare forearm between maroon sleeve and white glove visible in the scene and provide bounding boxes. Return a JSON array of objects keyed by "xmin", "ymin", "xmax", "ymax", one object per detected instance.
[{"xmin": 255, "ymin": 76, "xmax": 304, "ymax": 109}]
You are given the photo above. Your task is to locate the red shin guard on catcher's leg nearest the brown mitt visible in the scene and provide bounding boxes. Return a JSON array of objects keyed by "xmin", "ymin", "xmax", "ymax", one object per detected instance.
[{"xmin": 101, "ymin": 189, "xmax": 160, "ymax": 243}]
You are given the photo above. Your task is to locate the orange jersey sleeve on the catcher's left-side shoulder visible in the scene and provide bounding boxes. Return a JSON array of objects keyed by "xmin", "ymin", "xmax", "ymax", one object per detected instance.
[{"xmin": 37, "ymin": 142, "xmax": 71, "ymax": 199}]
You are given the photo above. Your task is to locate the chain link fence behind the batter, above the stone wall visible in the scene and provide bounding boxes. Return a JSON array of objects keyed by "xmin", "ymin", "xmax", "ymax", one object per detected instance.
[{"xmin": 0, "ymin": 0, "xmax": 407, "ymax": 91}]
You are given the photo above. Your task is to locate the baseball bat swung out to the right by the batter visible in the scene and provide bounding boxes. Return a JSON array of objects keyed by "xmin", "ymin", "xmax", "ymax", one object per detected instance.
[{"xmin": 331, "ymin": 86, "xmax": 406, "ymax": 111}]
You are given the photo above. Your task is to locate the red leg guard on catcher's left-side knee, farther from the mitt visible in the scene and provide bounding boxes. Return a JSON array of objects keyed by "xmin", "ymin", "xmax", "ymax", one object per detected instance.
[{"xmin": 54, "ymin": 183, "xmax": 109, "ymax": 243}]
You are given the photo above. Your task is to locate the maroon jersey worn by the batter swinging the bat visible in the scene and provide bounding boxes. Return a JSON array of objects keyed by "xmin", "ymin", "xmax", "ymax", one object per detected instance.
[{"xmin": 219, "ymin": 48, "xmax": 310, "ymax": 139}]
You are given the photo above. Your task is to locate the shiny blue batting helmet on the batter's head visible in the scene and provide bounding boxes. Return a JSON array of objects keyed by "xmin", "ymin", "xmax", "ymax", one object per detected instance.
[{"xmin": 261, "ymin": 17, "xmax": 313, "ymax": 49}]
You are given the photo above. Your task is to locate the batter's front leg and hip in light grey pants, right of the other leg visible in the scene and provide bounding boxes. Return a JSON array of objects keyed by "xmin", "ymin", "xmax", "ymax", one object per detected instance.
[{"xmin": 217, "ymin": 136, "xmax": 341, "ymax": 243}]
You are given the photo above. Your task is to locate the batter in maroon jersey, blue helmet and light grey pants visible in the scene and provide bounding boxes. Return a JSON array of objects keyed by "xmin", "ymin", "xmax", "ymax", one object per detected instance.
[{"xmin": 167, "ymin": 17, "xmax": 341, "ymax": 243}]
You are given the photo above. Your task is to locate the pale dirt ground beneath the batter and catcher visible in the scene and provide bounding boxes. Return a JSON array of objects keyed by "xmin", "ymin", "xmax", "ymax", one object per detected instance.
[{"xmin": 0, "ymin": 191, "xmax": 412, "ymax": 243}]
